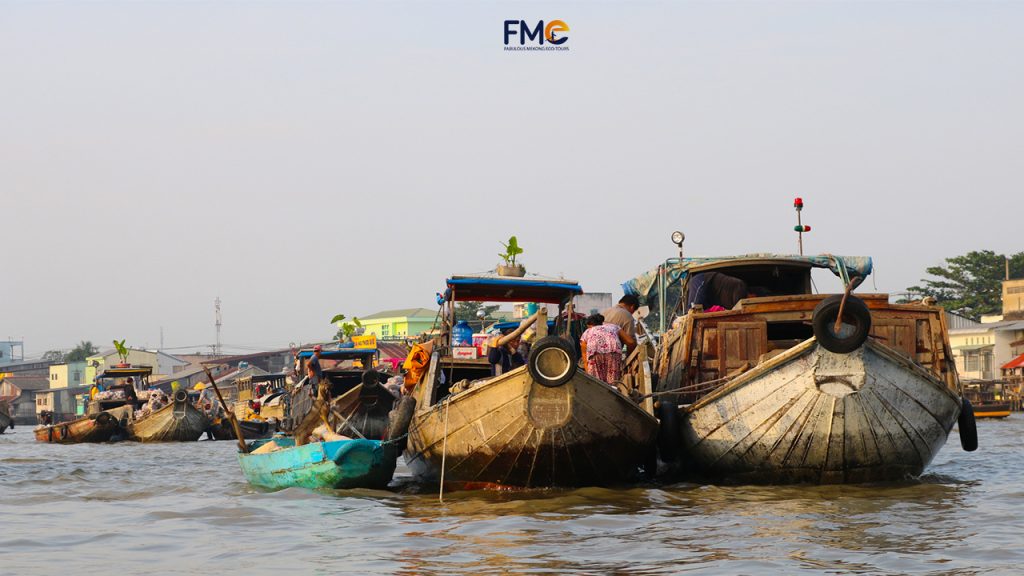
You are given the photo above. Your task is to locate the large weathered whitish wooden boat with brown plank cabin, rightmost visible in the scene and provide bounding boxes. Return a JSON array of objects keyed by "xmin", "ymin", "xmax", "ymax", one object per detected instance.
[{"xmin": 626, "ymin": 251, "xmax": 977, "ymax": 483}]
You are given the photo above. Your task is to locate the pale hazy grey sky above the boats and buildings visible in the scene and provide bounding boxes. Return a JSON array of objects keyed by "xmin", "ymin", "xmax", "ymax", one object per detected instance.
[{"xmin": 0, "ymin": 0, "xmax": 1024, "ymax": 357}]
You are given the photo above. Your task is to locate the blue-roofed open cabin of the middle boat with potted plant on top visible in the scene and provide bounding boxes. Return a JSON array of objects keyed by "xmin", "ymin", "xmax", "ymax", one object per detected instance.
[{"xmin": 421, "ymin": 275, "xmax": 584, "ymax": 405}]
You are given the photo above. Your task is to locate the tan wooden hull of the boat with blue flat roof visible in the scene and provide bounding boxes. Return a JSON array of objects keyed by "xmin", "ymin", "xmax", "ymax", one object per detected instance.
[{"xmin": 406, "ymin": 367, "xmax": 657, "ymax": 488}]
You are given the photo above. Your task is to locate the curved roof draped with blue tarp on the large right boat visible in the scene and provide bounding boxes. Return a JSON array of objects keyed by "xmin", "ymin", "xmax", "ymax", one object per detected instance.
[{"xmin": 623, "ymin": 253, "xmax": 872, "ymax": 298}]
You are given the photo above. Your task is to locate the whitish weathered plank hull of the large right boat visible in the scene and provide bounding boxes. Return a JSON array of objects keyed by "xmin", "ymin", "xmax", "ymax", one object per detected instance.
[{"xmin": 682, "ymin": 338, "xmax": 962, "ymax": 484}]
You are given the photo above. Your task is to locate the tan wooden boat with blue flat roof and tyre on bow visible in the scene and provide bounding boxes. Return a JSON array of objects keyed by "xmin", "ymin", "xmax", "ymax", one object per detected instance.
[{"xmin": 406, "ymin": 275, "xmax": 657, "ymax": 488}]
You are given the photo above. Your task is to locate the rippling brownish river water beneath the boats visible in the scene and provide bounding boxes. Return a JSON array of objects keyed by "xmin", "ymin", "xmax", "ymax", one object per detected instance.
[{"xmin": 0, "ymin": 414, "xmax": 1024, "ymax": 576}]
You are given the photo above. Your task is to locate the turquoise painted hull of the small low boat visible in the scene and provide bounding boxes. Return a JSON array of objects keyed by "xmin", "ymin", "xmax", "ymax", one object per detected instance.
[{"xmin": 239, "ymin": 438, "xmax": 398, "ymax": 489}]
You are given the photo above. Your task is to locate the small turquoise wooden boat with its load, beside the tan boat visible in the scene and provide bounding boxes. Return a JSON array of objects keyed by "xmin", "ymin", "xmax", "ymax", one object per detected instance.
[{"xmin": 239, "ymin": 384, "xmax": 416, "ymax": 489}]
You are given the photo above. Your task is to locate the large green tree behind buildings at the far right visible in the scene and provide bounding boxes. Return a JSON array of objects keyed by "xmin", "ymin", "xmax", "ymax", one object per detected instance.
[{"xmin": 907, "ymin": 250, "xmax": 1024, "ymax": 319}]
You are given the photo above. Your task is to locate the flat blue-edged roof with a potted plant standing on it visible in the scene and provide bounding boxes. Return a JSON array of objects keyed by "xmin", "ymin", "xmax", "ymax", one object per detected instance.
[{"xmin": 445, "ymin": 273, "xmax": 583, "ymax": 304}]
